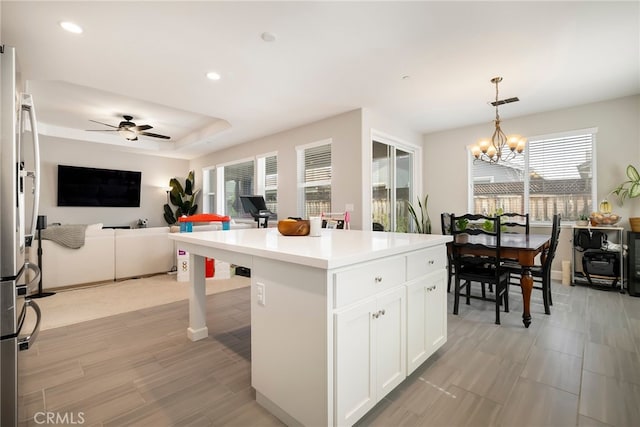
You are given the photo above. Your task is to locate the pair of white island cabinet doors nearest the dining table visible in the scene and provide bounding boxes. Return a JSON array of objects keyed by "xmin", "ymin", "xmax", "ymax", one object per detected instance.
[{"xmin": 407, "ymin": 270, "xmax": 447, "ymax": 375}]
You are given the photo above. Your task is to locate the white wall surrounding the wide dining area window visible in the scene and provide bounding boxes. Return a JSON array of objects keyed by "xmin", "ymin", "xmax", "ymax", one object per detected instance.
[{"xmin": 424, "ymin": 95, "xmax": 640, "ymax": 269}]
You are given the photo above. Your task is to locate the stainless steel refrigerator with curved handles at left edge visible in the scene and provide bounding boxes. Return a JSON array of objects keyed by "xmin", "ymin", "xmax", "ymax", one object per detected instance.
[{"xmin": 0, "ymin": 46, "xmax": 40, "ymax": 427}]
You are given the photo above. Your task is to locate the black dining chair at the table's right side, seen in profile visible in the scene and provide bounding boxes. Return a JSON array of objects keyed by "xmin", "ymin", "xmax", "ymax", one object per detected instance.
[{"xmin": 502, "ymin": 214, "xmax": 561, "ymax": 314}]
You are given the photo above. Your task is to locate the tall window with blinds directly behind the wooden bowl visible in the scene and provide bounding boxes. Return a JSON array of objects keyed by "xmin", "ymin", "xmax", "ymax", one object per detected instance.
[{"xmin": 296, "ymin": 140, "xmax": 331, "ymax": 218}]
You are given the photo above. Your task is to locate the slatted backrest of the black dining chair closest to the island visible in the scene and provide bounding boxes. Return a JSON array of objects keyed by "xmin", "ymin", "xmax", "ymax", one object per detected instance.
[{"xmin": 450, "ymin": 214, "xmax": 501, "ymax": 279}]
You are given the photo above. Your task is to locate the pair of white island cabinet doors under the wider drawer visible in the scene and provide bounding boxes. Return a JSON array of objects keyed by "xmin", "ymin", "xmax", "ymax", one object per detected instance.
[{"xmin": 335, "ymin": 286, "xmax": 406, "ymax": 425}]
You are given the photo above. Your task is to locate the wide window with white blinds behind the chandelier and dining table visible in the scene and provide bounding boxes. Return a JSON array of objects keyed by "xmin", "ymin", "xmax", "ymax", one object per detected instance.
[{"xmin": 470, "ymin": 129, "xmax": 596, "ymax": 222}]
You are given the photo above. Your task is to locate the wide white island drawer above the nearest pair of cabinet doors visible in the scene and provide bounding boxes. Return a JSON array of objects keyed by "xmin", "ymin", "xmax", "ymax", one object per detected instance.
[{"xmin": 333, "ymin": 256, "xmax": 406, "ymax": 308}]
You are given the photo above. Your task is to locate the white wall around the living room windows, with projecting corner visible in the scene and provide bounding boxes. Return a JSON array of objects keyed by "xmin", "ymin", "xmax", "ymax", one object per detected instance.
[{"xmin": 190, "ymin": 109, "xmax": 422, "ymax": 229}]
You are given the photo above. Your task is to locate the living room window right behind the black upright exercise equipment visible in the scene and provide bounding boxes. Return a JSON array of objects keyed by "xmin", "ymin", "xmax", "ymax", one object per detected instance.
[{"xmin": 218, "ymin": 160, "xmax": 255, "ymax": 218}]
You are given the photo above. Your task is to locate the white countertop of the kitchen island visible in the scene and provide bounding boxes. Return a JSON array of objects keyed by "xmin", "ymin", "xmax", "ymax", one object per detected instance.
[{"xmin": 169, "ymin": 228, "xmax": 451, "ymax": 269}]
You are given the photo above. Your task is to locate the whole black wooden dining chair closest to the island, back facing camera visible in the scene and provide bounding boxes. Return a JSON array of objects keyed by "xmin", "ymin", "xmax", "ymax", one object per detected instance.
[{"xmin": 451, "ymin": 214, "xmax": 509, "ymax": 325}]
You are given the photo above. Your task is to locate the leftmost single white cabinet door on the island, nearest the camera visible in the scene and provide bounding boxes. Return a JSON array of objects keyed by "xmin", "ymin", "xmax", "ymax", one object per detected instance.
[{"xmin": 335, "ymin": 299, "xmax": 377, "ymax": 426}]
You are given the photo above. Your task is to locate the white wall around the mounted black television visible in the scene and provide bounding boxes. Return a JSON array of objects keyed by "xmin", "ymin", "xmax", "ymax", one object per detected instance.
[{"xmin": 40, "ymin": 135, "xmax": 188, "ymax": 227}]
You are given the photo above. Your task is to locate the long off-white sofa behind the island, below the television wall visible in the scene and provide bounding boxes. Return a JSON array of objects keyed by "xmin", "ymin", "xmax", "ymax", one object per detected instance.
[{"xmin": 38, "ymin": 223, "xmax": 255, "ymax": 289}]
